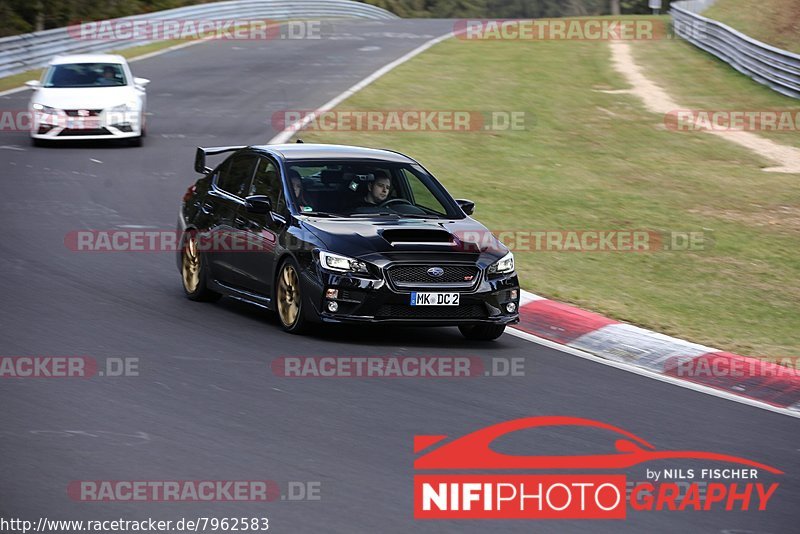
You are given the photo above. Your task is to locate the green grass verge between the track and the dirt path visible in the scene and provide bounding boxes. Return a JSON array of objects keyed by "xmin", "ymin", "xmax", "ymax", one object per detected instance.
[{"xmin": 294, "ymin": 24, "xmax": 800, "ymax": 357}]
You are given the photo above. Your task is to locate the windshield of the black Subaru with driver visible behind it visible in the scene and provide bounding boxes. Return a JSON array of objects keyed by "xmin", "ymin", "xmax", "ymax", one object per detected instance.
[{"xmin": 287, "ymin": 161, "xmax": 464, "ymax": 219}]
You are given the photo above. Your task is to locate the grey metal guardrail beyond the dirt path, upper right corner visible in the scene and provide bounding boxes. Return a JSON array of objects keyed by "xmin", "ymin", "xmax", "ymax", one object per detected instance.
[{"xmin": 670, "ymin": 0, "xmax": 800, "ymax": 98}]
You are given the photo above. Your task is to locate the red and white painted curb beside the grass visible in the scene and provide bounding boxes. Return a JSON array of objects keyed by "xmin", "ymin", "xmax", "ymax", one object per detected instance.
[{"xmin": 511, "ymin": 291, "xmax": 800, "ymax": 417}]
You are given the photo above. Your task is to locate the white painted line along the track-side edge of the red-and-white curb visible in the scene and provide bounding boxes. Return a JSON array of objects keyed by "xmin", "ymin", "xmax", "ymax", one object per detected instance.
[{"xmin": 506, "ymin": 327, "xmax": 800, "ymax": 419}]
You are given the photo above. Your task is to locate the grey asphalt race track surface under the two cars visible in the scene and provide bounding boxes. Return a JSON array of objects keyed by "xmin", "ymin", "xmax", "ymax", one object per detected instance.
[{"xmin": 0, "ymin": 20, "xmax": 800, "ymax": 534}]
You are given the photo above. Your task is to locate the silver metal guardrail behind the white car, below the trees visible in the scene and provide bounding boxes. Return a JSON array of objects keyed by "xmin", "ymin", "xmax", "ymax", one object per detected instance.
[{"xmin": 0, "ymin": 0, "xmax": 398, "ymax": 77}]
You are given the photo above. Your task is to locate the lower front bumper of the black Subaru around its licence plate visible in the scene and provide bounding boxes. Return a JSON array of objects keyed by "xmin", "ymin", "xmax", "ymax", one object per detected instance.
[{"xmin": 306, "ymin": 270, "xmax": 520, "ymax": 326}]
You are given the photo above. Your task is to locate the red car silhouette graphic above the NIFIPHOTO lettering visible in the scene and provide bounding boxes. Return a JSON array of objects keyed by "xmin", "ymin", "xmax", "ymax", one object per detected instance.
[{"xmin": 414, "ymin": 416, "xmax": 783, "ymax": 475}]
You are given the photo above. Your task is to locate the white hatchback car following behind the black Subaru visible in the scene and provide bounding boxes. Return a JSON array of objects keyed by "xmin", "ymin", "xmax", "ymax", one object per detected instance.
[{"xmin": 25, "ymin": 54, "xmax": 150, "ymax": 146}]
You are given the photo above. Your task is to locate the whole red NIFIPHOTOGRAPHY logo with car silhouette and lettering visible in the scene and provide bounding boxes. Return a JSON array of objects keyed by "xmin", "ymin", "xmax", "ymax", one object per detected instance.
[{"xmin": 414, "ymin": 416, "xmax": 783, "ymax": 520}]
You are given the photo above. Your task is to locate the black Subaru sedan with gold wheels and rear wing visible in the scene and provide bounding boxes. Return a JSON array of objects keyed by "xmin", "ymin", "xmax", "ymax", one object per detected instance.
[{"xmin": 178, "ymin": 143, "xmax": 520, "ymax": 340}]
